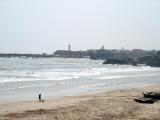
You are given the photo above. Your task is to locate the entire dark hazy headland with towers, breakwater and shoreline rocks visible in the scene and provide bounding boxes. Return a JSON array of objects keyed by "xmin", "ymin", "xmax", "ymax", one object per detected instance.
[{"xmin": 0, "ymin": 45, "xmax": 160, "ymax": 67}]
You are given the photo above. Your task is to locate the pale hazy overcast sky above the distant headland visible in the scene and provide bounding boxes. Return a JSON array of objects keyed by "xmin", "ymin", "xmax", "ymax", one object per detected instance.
[{"xmin": 0, "ymin": 0, "xmax": 160, "ymax": 53}]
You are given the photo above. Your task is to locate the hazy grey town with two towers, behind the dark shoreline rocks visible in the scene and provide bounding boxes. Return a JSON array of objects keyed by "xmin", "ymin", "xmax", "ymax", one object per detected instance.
[{"xmin": 53, "ymin": 45, "xmax": 153, "ymax": 60}]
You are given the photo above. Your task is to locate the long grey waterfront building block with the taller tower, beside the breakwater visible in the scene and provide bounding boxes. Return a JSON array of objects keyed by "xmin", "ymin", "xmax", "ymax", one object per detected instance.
[{"xmin": 53, "ymin": 44, "xmax": 89, "ymax": 58}]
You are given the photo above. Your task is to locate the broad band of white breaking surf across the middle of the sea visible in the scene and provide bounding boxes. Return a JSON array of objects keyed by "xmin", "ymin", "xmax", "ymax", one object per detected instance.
[{"xmin": 0, "ymin": 66, "xmax": 159, "ymax": 83}]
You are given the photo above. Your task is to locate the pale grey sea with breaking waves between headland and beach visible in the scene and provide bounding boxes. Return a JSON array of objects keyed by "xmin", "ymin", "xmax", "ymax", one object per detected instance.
[{"xmin": 0, "ymin": 58, "xmax": 160, "ymax": 101}]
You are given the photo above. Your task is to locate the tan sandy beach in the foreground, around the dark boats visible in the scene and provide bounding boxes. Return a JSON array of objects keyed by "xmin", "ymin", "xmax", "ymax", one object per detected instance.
[{"xmin": 0, "ymin": 85, "xmax": 160, "ymax": 120}]
